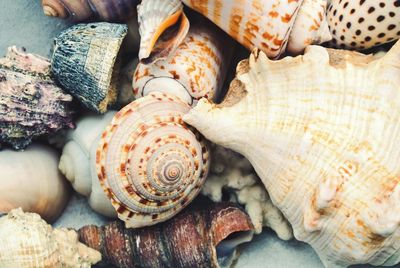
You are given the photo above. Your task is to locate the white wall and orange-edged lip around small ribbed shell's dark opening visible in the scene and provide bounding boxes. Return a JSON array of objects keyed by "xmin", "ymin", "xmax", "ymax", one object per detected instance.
[{"xmin": 138, "ymin": 0, "xmax": 189, "ymax": 60}]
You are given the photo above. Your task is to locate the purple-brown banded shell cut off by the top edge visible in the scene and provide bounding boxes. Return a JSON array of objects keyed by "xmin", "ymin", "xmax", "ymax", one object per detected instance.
[{"xmin": 42, "ymin": 0, "xmax": 139, "ymax": 22}]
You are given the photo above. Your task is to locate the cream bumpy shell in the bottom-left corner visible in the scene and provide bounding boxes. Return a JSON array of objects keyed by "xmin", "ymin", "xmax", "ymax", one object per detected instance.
[{"xmin": 0, "ymin": 209, "xmax": 101, "ymax": 268}]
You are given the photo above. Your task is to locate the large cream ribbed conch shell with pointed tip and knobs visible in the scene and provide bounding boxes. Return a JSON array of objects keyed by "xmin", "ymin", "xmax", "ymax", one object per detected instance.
[{"xmin": 184, "ymin": 42, "xmax": 400, "ymax": 267}]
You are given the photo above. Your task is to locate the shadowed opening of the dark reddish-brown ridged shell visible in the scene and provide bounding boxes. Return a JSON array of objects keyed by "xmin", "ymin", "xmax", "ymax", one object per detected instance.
[{"xmin": 216, "ymin": 231, "xmax": 254, "ymax": 267}]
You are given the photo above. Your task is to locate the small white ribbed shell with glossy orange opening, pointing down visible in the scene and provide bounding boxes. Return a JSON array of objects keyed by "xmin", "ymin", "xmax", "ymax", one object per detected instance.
[{"xmin": 138, "ymin": 0, "xmax": 190, "ymax": 62}]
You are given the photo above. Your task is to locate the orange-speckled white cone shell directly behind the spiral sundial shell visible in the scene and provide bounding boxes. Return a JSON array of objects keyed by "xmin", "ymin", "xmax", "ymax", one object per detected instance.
[{"xmin": 133, "ymin": 23, "xmax": 234, "ymax": 105}]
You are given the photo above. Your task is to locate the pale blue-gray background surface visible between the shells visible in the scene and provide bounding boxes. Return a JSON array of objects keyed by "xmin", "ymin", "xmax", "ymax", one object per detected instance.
[{"xmin": 0, "ymin": 0, "xmax": 380, "ymax": 268}]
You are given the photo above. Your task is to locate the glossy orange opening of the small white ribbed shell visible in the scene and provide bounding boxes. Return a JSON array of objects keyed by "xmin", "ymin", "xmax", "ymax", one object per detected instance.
[{"xmin": 139, "ymin": 10, "xmax": 190, "ymax": 64}]
